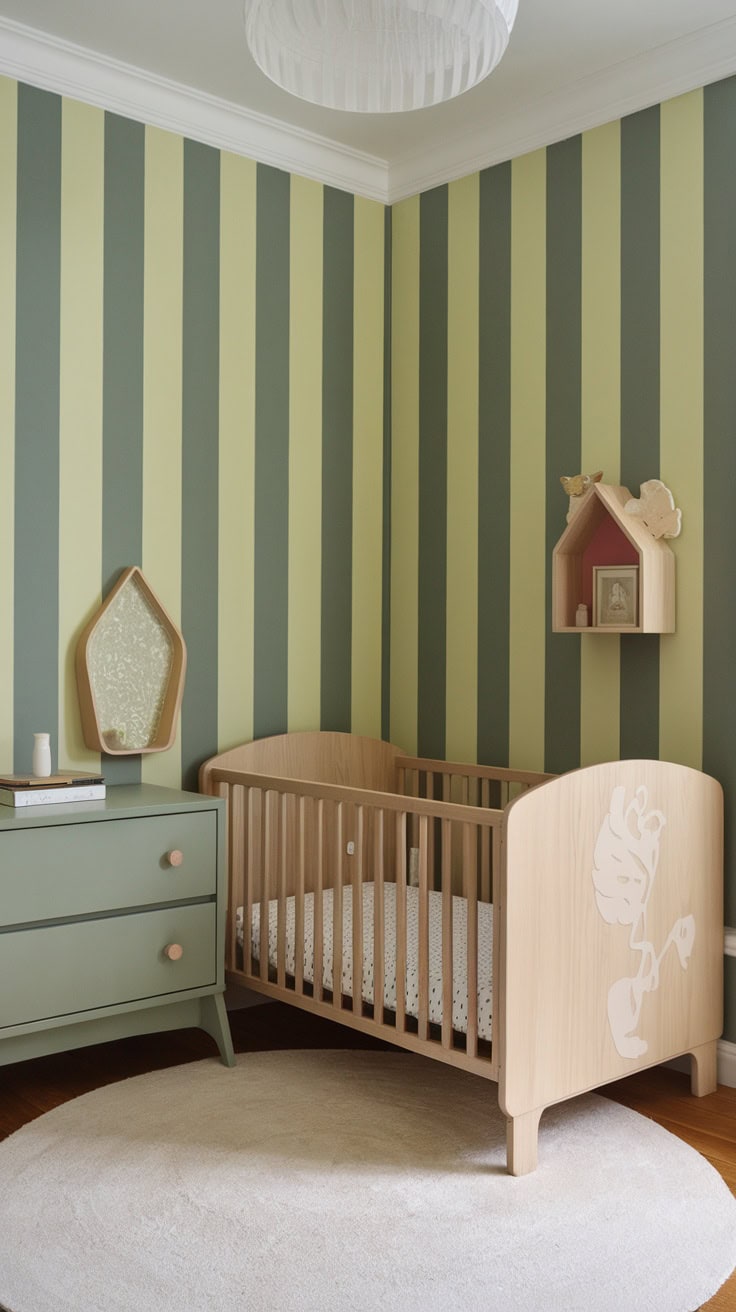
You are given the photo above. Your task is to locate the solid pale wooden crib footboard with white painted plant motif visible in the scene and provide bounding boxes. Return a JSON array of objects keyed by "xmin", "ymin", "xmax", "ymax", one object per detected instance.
[{"xmin": 496, "ymin": 761, "xmax": 723, "ymax": 1173}]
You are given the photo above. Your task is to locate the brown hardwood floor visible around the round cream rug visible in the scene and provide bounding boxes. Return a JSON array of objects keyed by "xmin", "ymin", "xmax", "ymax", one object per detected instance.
[{"xmin": 0, "ymin": 1002, "xmax": 736, "ymax": 1312}]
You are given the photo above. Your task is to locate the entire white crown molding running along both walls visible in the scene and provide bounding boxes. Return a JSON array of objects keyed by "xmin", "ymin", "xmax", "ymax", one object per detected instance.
[{"xmin": 0, "ymin": 17, "xmax": 736, "ymax": 205}]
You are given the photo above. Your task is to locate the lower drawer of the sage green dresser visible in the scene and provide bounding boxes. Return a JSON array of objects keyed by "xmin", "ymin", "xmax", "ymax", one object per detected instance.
[{"xmin": 0, "ymin": 903, "xmax": 216, "ymax": 1030}]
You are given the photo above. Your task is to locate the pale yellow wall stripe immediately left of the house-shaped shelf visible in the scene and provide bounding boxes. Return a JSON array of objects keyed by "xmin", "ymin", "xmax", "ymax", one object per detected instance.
[{"xmin": 509, "ymin": 151, "xmax": 547, "ymax": 770}]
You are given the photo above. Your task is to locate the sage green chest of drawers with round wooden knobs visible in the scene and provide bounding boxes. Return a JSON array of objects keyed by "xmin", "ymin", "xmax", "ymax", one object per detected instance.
[{"xmin": 0, "ymin": 785, "xmax": 235, "ymax": 1065}]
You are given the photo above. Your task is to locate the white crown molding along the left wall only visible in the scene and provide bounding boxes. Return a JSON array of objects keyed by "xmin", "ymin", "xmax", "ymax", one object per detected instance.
[{"xmin": 0, "ymin": 17, "xmax": 388, "ymax": 203}]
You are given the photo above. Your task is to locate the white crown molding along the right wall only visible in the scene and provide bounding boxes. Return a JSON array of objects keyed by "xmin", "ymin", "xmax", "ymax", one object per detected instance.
[{"xmin": 388, "ymin": 18, "xmax": 736, "ymax": 205}]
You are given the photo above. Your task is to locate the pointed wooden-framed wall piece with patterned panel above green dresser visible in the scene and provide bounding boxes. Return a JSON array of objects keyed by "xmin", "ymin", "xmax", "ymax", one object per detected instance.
[{"xmin": 76, "ymin": 565, "xmax": 186, "ymax": 756}]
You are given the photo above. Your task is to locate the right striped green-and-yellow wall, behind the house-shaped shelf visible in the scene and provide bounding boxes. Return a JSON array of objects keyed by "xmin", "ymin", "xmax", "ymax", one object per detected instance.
[{"xmin": 391, "ymin": 80, "xmax": 736, "ymax": 955}]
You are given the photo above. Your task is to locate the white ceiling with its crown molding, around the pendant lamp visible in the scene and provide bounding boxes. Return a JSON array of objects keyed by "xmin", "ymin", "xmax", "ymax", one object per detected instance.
[{"xmin": 0, "ymin": 0, "xmax": 736, "ymax": 201}]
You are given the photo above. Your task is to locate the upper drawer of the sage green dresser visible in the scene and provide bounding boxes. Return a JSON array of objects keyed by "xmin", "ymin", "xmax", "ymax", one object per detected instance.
[{"xmin": 0, "ymin": 811, "xmax": 218, "ymax": 925}]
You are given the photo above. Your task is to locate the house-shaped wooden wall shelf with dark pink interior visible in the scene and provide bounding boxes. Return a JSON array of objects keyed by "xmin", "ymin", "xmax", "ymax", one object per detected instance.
[{"xmin": 552, "ymin": 483, "xmax": 674, "ymax": 634}]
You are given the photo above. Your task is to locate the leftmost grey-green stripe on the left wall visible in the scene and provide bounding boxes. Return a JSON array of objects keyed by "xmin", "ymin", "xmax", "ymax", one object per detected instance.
[{"xmin": 13, "ymin": 84, "xmax": 62, "ymax": 770}]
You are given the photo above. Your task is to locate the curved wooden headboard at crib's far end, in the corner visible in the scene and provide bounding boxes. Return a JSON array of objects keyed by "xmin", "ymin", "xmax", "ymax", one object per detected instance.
[{"xmin": 199, "ymin": 731, "xmax": 404, "ymax": 792}]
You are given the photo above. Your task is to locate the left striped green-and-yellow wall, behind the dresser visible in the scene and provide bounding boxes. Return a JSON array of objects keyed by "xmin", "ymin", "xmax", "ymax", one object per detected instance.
[{"xmin": 0, "ymin": 80, "xmax": 388, "ymax": 786}]
